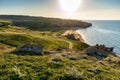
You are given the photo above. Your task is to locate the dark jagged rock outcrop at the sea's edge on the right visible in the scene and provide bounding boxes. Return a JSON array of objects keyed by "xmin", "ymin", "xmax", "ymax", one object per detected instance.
[{"xmin": 84, "ymin": 44, "xmax": 116, "ymax": 57}]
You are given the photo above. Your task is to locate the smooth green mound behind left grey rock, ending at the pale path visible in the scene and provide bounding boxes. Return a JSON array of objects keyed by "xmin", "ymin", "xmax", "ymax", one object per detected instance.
[{"xmin": 0, "ymin": 33, "xmax": 69, "ymax": 50}]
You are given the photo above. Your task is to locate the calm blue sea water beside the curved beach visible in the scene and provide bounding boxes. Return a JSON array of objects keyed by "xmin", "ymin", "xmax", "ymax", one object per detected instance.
[{"xmin": 77, "ymin": 20, "xmax": 120, "ymax": 55}]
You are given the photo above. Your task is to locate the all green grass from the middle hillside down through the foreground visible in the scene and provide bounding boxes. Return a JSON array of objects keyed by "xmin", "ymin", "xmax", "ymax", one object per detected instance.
[{"xmin": 0, "ymin": 26, "xmax": 120, "ymax": 80}]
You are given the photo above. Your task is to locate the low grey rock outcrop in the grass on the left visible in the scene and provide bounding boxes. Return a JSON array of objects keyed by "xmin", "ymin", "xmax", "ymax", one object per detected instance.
[{"xmin": 15, "ymin": 44, "xmax": 43, "ymax": 55}]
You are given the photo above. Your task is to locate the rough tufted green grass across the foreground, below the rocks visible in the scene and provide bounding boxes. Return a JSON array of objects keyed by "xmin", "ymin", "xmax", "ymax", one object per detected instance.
[{"xmin": 0, "ymin": 53, "xmax": 120, "ymax": 80}]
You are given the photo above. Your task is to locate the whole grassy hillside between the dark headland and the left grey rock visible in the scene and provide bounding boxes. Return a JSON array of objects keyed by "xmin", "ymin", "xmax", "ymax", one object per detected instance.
[{"xmin": 0, "ymin": 26, "xmax": 88, "ymax": 51}]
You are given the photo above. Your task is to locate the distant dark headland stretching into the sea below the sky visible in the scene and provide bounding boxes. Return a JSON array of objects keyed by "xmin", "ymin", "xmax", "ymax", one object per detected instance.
[{"xmin": 0, "ymin": 15, "xmax": 92, "ymax": 31}]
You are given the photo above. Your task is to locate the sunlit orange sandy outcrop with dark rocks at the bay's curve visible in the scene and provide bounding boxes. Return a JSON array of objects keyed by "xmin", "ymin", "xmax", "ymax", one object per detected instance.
[{"xmin": 62, "ymin": 30, "xmax": 84, "ymax": 42}]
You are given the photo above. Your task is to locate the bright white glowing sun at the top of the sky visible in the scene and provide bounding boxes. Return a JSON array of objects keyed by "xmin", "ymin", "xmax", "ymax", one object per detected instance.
[{"xmin": 59, "ymin": 0, "xmax": 82, "ymax": 13}]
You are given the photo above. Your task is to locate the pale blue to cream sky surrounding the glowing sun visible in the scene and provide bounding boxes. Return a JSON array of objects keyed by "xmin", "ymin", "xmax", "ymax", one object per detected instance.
[{"xmin": 0, "ymin": 0, "xmax": 120, "ymax": 20}]
